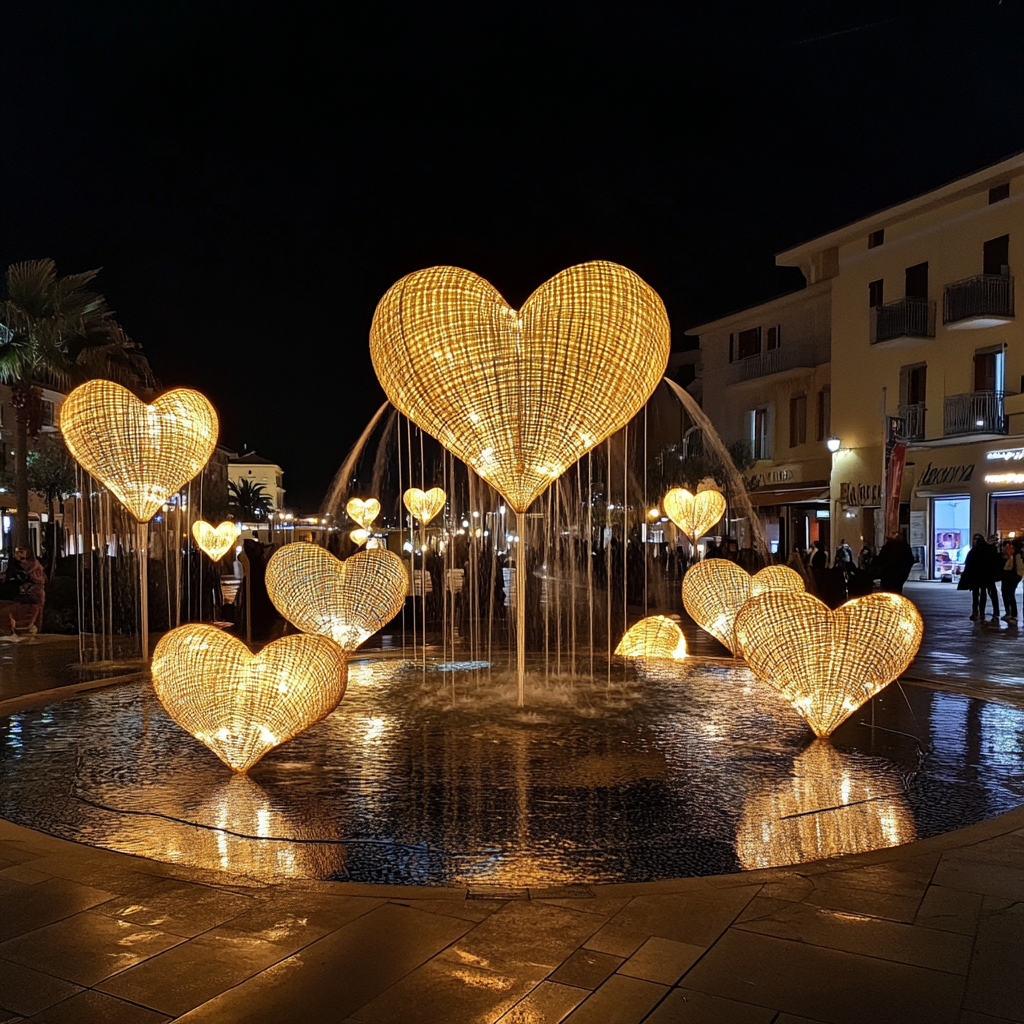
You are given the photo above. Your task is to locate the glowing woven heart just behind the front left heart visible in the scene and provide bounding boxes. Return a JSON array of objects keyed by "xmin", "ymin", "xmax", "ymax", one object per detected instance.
[{"xmin": 266, "ymin": 542, "xmax": 409, "ymax": 651}]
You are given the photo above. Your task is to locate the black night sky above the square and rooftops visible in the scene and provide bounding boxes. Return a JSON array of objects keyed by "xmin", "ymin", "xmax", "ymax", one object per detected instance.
[{"xmin": 0, "ymin": 0, "xmax": 1024, "ymax": 508}]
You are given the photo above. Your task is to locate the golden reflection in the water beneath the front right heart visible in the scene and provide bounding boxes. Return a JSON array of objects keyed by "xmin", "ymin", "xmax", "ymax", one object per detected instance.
[{"xmin": 736, "ymin": 740, "xmax": 918, "ymax": 870}]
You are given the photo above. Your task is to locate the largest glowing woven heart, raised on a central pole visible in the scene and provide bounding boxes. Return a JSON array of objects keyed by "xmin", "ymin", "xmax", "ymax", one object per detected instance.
[{"xmin": 370, "ymin": 261, "xmax": 671, "ymax": 512}]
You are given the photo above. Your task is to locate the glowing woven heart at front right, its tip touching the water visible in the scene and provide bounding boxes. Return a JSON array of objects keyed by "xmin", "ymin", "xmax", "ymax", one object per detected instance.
[{"xmin": 735, "ymin": 591, "xmax": 924, "ymax": 736}]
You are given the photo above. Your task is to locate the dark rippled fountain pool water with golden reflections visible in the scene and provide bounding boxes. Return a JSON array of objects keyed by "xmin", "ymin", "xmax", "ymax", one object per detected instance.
[{"xmin": 0, "ymin": 658, "xmax": 1024, "ymax": 886}]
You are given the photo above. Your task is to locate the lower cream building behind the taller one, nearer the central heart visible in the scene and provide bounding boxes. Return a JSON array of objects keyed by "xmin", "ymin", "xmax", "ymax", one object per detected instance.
[{"xmin": 686, "ymin": 282, "xmax": 831, "ymax": 558}]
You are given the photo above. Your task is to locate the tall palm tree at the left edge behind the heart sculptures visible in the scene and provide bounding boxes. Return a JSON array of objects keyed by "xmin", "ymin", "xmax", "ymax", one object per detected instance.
[{"xmin": 0, "ymin": 259, "xmax": 156, "ymax": 545}]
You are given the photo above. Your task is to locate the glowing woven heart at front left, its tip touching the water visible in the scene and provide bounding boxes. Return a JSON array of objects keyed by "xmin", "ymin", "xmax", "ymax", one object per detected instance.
[{"xmin": 153, "ymin": 624, "xmax": 347, "ymax": 771}]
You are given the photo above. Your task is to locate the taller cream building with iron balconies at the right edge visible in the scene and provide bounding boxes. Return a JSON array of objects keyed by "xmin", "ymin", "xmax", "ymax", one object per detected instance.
[{"xmin": 774, "ymin": 154, "xmax": 1024, "ymax": 578}]
